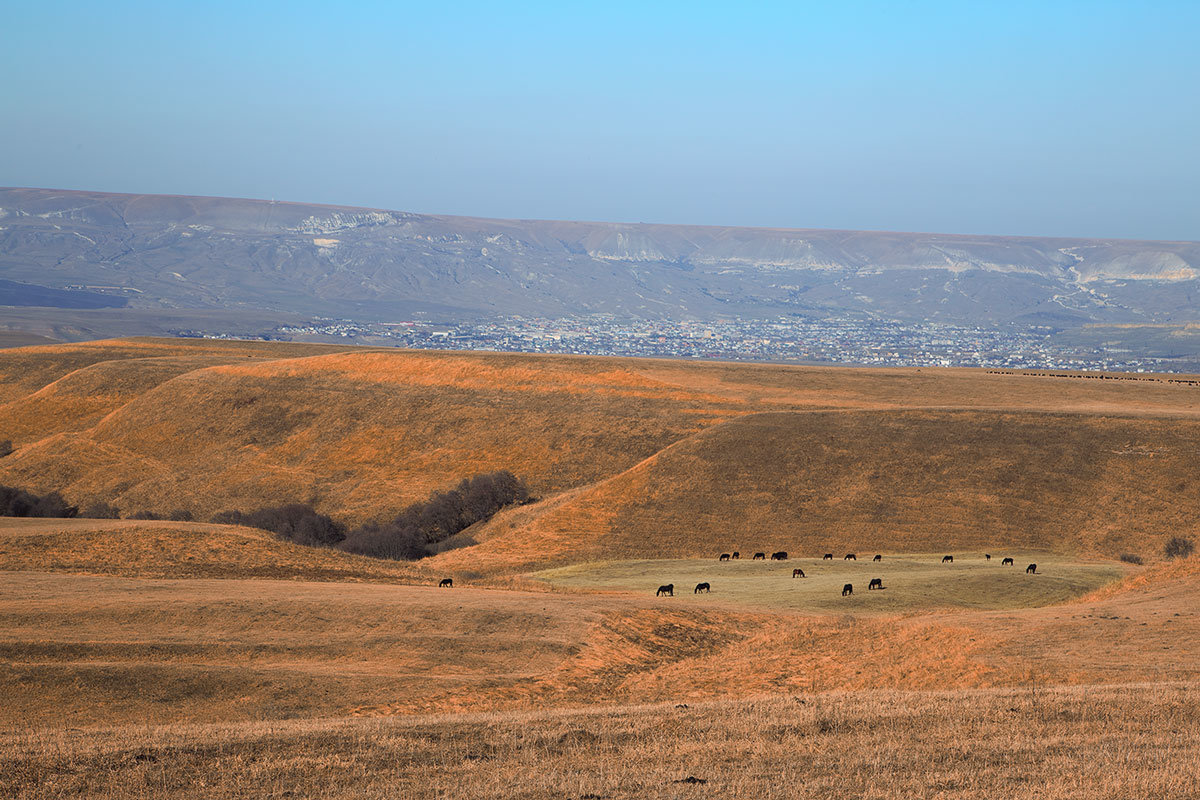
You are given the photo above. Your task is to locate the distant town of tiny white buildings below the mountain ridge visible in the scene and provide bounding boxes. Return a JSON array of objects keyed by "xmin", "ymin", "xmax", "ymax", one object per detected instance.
[{"xmin": 166, "ymin": 314, "xmax": 1195, "ymax": 373}]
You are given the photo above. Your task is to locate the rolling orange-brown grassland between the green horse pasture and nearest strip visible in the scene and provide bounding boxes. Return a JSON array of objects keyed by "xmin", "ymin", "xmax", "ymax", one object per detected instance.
[{"xmin": 0, "ymin": 537, "xmax": 1200, "ymax": 727}]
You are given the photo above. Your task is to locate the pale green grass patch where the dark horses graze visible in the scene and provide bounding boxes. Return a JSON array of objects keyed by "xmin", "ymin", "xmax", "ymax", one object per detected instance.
[{"xmin": 534, "ymin": 552, "xmax": 1123, "ymax": 614}]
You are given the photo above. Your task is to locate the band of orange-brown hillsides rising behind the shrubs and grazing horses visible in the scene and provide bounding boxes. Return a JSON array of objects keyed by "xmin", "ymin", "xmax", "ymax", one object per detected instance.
[{"xmin": 0, "ymin": 339, "xmax": 1200, "ymax": 527}]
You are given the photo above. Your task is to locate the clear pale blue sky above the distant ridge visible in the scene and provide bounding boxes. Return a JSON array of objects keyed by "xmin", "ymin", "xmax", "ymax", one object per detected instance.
[{"xmin": 0, "ymin": 0, "xmax": 1200, "ymax": 240}]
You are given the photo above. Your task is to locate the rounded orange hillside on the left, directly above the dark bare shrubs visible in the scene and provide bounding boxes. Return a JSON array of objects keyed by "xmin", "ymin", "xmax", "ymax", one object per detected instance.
[{"xmin": 0, "ymin": 350, "xmax": 738, "ymax": 519}]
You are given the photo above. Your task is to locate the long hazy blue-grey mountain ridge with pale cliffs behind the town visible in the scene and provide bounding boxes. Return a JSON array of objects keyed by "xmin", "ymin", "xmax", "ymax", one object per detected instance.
[{"xmin": 0, "ymin": 188, "xmax": 1200, "ymax": 325}]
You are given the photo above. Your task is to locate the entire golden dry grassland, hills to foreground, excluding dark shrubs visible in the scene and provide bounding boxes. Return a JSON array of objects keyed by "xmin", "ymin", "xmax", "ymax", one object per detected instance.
[{"xmin": 0, "ymin": 339, "xmax": 1200, "ymax": 800}]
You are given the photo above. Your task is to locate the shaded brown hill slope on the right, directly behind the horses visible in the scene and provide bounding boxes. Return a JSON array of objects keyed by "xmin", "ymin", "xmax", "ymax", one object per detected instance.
[{"xmin": 439, "ymin": 410, "xmax": 1200, "ymax": 569}]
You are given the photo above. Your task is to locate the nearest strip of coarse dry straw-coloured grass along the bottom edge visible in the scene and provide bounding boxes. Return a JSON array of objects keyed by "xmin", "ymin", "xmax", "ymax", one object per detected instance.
[{"xmin": 0, "ymin": 685, "xmax": 1200, "ymax": 800}]
